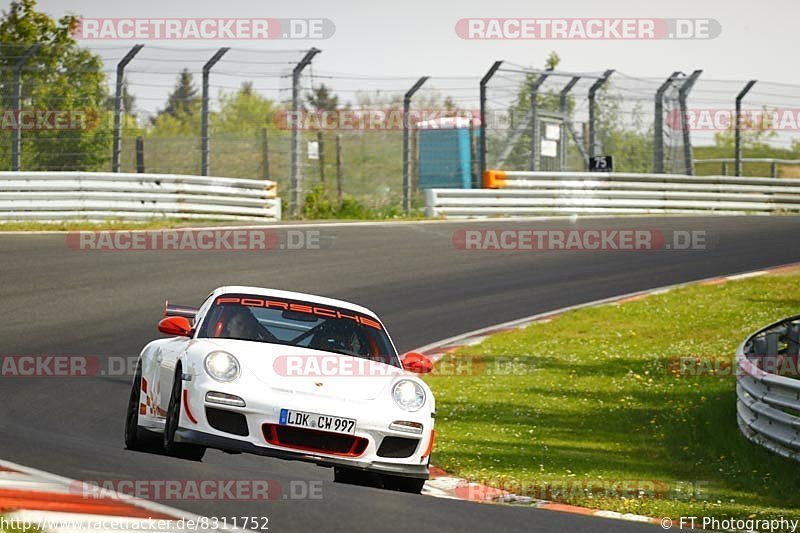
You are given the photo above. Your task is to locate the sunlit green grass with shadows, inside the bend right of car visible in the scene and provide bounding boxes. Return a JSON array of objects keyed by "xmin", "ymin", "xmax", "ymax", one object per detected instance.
[{"xmin": 427, "ymin": 266, "xmax": 800, "ymax": 518}]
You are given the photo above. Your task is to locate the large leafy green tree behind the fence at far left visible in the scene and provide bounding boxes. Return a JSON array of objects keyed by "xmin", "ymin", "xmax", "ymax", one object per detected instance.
[{"xmin": 0, "ymin": 0, "xmax": 111, "ymax": 170}]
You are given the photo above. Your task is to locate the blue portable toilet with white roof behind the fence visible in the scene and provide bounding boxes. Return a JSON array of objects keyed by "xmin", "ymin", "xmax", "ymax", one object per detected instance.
[{"xmin": 417, "ymin": 117, "xmax": 480, "ymax": 189}]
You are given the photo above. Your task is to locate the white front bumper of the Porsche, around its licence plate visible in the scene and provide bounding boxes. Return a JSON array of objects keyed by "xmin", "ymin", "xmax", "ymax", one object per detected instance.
[{"xmin": 176, "ymin": 374, "xmax": 434, "ymax": 479}]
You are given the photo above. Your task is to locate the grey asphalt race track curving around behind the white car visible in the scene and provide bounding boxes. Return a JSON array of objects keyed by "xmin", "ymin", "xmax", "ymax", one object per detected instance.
[{"xmin": 0, "ymin": 217, "xmax": 800, "ymax": 533}]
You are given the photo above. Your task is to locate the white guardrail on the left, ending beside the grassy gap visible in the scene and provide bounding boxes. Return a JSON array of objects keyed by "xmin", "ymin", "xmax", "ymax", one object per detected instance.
[{"xmin": 0, "ymin": 172, "xmax": 281, "ymax": 221}]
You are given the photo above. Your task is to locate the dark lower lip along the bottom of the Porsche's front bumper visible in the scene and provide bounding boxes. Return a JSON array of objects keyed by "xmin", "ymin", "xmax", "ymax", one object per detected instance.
[{"xmin": 175, "ymin": 428, "xmax": 430, "ymax": 479}]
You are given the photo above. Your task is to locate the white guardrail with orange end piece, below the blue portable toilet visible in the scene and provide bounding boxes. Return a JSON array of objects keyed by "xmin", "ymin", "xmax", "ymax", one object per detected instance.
[{"xmin": 425, "ymin": 170, "xmax": 800, "ymax": 217}]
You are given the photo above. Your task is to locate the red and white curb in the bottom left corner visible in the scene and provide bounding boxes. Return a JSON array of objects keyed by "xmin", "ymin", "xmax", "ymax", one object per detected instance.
[{"xmin": 0, "ymin": 460, "xmax": 243, "ymax": 533}]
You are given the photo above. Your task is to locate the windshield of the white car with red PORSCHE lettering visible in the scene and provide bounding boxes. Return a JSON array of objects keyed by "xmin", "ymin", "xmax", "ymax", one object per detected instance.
[{"xmin": 197, "ymin": 294, "xmax": 401, "ymax": 367}]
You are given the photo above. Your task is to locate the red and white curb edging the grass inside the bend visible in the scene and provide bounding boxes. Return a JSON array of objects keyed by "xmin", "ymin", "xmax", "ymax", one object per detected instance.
[{"xmin": 414, "ymin": 263, "xmax": 800, "ymax": 524}]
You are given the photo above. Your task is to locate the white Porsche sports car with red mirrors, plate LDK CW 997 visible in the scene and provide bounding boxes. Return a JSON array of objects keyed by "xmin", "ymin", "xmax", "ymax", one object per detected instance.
[{"xmin": 125, "ymin": 287, "xmax": 435, "ymax": 492}]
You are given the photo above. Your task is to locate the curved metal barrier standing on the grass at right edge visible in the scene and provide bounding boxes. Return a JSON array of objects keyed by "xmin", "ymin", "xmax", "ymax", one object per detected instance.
[{"xmin": 736, "ymin": 315, "xmax": 800, "ymax": 461}]
